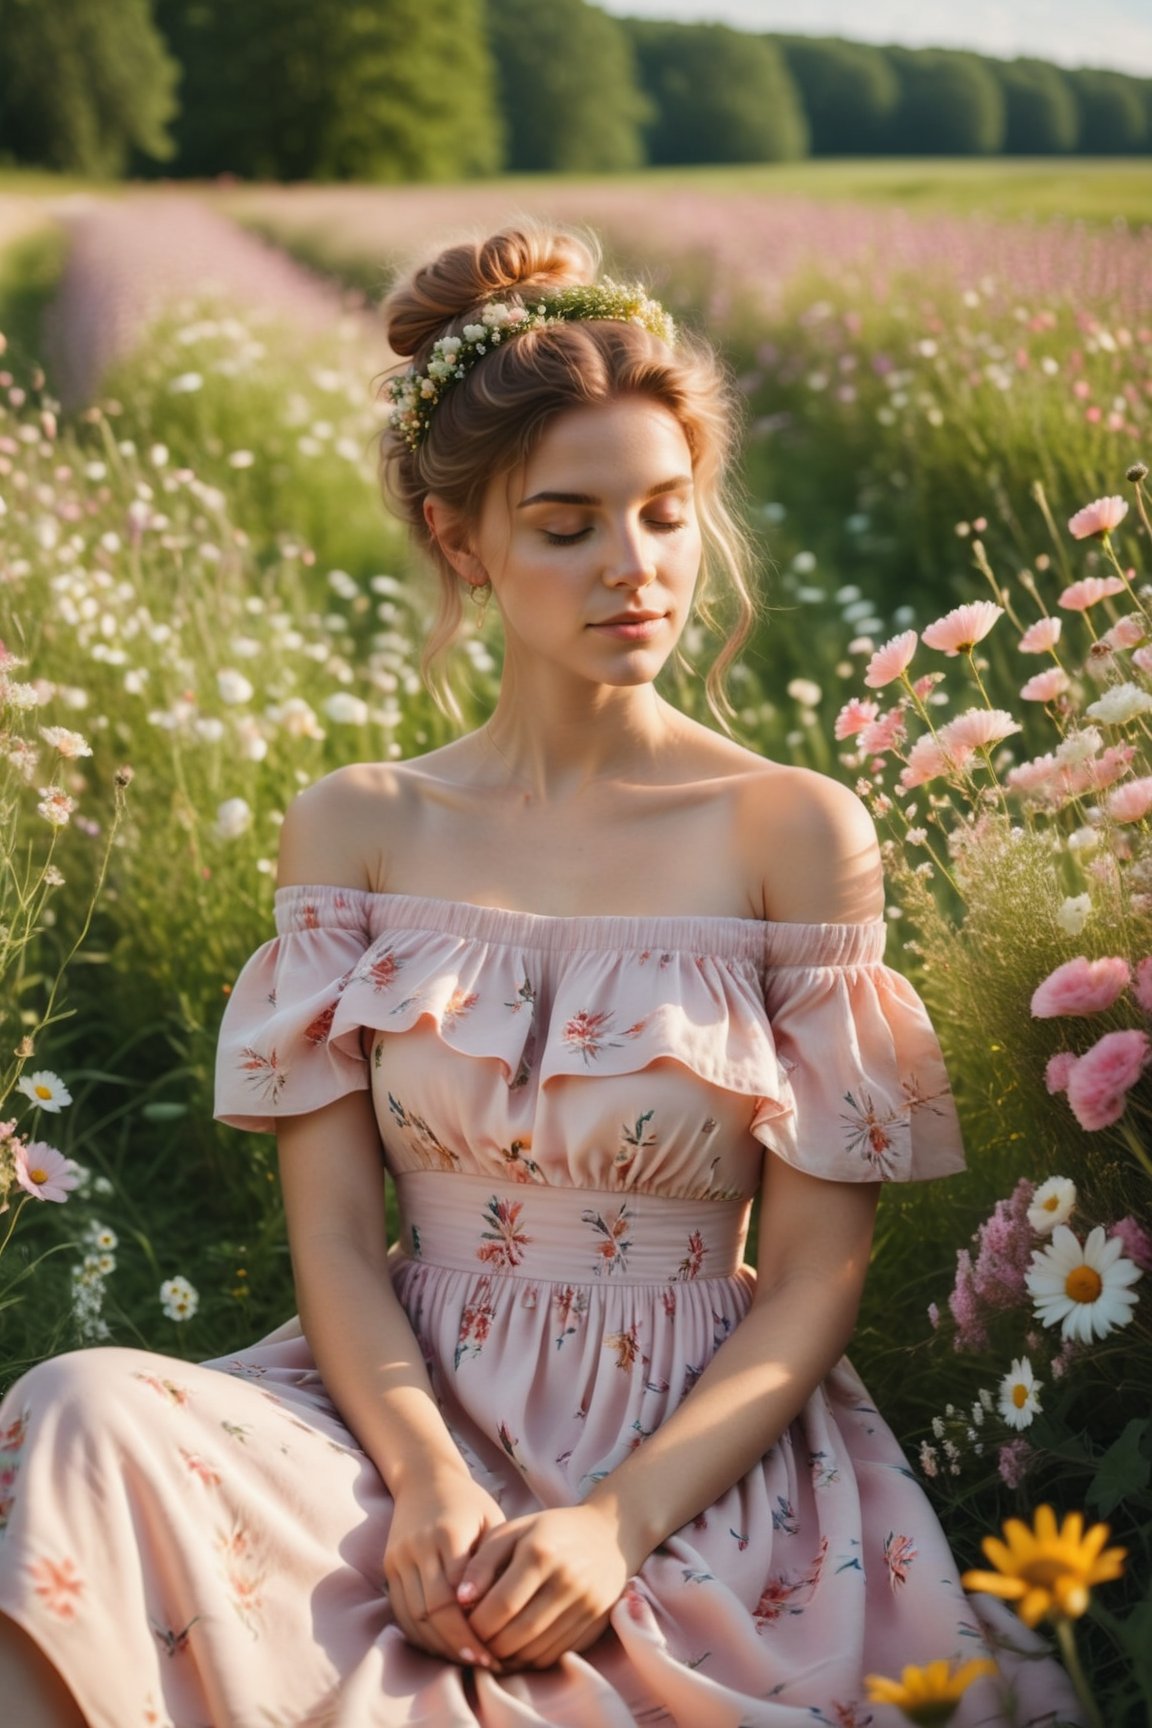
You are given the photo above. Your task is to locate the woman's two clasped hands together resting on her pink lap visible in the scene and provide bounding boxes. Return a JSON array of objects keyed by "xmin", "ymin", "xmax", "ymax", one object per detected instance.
[{"xmin": 383, "ymin": 1477, "xmax": 630, "ymax": 1673}]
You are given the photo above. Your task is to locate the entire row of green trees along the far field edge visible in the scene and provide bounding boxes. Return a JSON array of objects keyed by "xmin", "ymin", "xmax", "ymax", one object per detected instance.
[{"xmin": 0, "ymin": 0, "xmax": 1152, "ymax": 181}]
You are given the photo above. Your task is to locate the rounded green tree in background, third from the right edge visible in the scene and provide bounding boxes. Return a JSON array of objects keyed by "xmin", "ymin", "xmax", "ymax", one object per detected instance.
[{"xmin": 888, "ymin": 47, "xmax": 1005, "ymax": 156}]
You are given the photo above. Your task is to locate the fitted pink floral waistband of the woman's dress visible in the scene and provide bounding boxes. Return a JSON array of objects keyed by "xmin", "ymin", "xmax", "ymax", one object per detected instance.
[{"xmin": 396, "ymin": 1170, "xmax": 751, "ymax": 1284}]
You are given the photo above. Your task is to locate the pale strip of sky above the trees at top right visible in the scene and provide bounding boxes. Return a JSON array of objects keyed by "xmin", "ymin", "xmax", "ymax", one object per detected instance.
[{"xmin": 599, "ymin": 0, "xmax": 1152, "ymax": 78}]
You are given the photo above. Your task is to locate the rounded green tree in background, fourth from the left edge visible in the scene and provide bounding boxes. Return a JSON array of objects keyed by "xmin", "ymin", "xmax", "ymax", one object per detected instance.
[{"xmin": 627, "ymin": 19, "xmax": 808, "ymax": 162}]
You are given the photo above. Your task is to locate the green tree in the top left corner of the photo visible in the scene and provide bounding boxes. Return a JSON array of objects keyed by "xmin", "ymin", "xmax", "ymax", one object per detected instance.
[{"xmin": 0, "ymin": 0, "xmax": 178, "ymax": 178}]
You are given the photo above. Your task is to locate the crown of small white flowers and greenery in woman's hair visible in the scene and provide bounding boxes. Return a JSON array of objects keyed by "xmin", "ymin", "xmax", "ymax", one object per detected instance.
[{"xmin": 389, "ymin": 276, "xmax": 675, "ymax": 449}]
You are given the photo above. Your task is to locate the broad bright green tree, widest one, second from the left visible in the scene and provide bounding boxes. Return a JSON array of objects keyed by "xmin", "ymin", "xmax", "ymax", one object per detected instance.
[{"xmin": 155, "ymin": 0, "xmax": 501, "ymax": 180}]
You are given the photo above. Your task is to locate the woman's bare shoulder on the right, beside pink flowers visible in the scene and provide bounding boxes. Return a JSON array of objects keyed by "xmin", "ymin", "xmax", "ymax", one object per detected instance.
[{"xmin": 739, "ymin": 762, "xmax": 884, "ymax": 924}]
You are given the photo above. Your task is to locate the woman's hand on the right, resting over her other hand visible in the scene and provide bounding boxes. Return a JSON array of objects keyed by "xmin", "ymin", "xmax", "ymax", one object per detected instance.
[{"xmin": 456, "ymin": 1505, "xmax": 632, "ymax": 1668}]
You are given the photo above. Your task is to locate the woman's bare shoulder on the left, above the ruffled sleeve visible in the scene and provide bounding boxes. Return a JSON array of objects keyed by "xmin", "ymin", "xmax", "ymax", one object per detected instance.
[{"xmin": 276, "ymin": 762, "xmax": 411, "ymax": 888}]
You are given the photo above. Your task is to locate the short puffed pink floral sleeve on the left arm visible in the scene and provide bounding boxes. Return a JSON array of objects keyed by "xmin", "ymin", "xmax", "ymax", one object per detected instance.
[{"xmin": 214, "ymin": 888, "xmax": 371, "ymax": 1134}]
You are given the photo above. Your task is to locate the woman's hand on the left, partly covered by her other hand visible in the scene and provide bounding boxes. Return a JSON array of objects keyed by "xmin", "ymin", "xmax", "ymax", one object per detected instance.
[{"xmin": 383, "ymin": 1464, "xmax": 504, "ymax": 1669}]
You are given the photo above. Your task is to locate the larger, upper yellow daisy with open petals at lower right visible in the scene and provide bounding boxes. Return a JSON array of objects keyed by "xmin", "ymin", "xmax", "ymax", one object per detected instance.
[{"xmin": 960, "ymin": 1505, "xmax": 1128, "ymax": 1626}]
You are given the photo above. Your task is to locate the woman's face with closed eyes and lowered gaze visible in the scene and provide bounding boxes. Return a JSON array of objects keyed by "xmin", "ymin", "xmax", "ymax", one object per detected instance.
[{"xmin": 470, "ymin": 396, "xmax": 701, "ymax": 686}]
